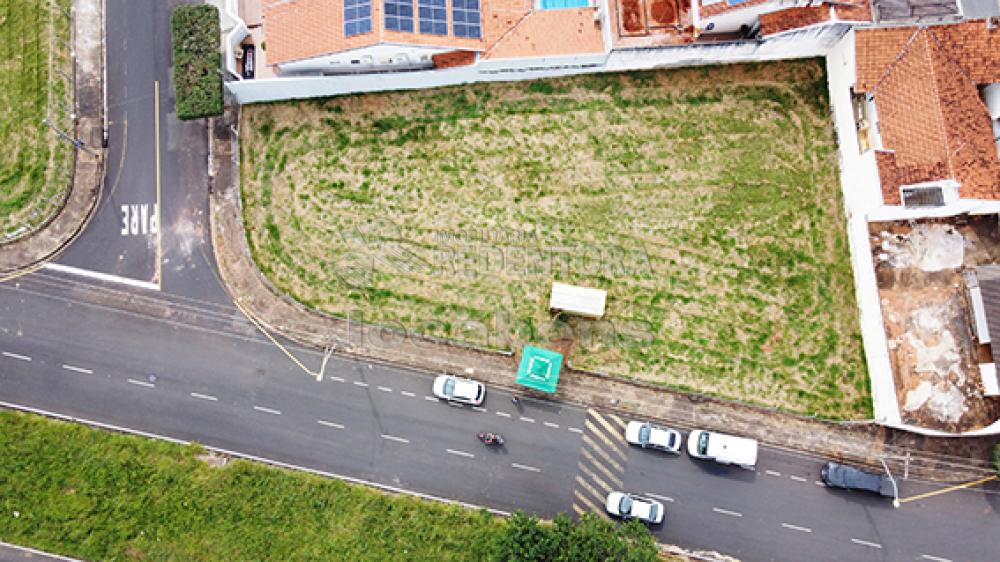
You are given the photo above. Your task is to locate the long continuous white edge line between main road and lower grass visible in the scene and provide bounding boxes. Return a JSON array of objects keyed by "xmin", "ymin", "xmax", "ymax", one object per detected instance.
[{"xmin": 0, "ymin": 401, "xmax": 510, "ymax": 517}]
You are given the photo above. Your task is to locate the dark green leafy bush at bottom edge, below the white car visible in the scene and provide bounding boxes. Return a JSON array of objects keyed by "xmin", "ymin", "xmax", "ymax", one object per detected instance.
[{"xmin": 493, "ymin": 512, "xmax": 659, "ymax": 562}]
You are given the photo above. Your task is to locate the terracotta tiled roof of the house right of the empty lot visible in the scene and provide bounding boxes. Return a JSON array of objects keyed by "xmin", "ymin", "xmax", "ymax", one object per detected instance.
[{"xmin": 855, "ymin": 21, "xmax": 1000, "ymax": 204}]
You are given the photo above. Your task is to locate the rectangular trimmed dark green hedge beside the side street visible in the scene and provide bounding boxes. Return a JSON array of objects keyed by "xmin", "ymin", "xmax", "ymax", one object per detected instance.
[{"xmin": 170, "ymin": 4, "xmax": 222, "ymax": 119}]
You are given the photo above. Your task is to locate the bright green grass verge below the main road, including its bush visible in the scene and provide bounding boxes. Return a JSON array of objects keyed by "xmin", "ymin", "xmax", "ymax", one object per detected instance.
[{"xmin": 0, "ymin": 411, "xmax": 652, "ymax": 562}]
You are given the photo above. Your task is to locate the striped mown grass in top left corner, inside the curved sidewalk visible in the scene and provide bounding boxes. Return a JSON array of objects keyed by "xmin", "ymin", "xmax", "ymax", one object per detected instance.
[{"xmin": 0, "ymin": 0, "xmax": 74, "ymax": 238}]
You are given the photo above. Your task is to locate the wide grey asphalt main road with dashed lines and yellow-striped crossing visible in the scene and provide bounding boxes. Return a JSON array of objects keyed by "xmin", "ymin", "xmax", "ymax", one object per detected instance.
[{"xmin": 0, "ymin": 274, "xmax": 1000, "ymax": 561}]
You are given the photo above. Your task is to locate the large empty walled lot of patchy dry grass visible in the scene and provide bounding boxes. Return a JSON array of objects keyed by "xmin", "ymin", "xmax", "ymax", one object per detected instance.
[{"xmin": 241, "ymin": 60, "xmax": 869, "ymax": 418}]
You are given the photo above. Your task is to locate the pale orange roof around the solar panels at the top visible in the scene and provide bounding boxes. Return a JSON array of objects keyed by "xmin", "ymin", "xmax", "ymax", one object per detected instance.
[{"xmin": 262, "ymin": 0, "xmax": 604, "ymax": 64}]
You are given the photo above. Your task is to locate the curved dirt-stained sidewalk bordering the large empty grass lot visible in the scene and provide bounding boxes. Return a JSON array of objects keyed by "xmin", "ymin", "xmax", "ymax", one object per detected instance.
[{"xmin": 209, "ymin": 104, "xmax": 992, "ymax": 481}]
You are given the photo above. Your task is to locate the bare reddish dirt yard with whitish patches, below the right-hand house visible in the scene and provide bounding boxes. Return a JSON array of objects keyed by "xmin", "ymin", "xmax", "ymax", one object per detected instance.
[{"xmin": 870, "ymin": 216, "xmax": 1000, "ymax": 432}]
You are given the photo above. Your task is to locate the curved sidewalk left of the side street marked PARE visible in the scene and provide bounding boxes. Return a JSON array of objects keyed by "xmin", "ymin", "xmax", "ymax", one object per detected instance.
[{"xmin": 0, "ymin": 0, "xmax": 105, "ymax": 281}]
